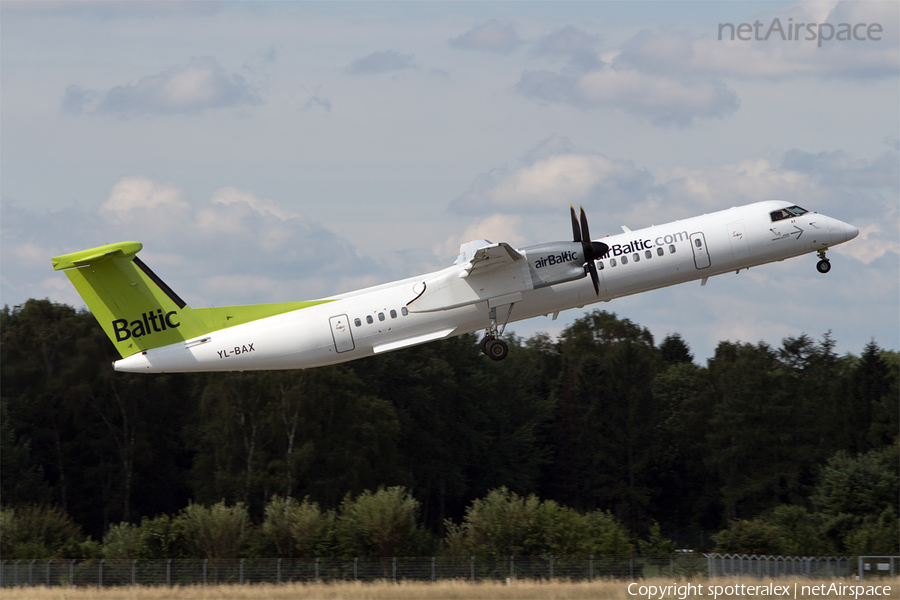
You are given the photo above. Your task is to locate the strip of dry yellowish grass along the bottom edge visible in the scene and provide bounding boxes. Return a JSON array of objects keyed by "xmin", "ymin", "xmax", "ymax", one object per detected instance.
[{"xmin": 0, "ymin": 578, "xmax": 900, "ymax": 600}]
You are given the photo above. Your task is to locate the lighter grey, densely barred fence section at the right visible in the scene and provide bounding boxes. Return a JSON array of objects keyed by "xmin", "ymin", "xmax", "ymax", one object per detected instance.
[{"xmin": 703, "ymin": 554, "xmax": 855, "ymax": 578}]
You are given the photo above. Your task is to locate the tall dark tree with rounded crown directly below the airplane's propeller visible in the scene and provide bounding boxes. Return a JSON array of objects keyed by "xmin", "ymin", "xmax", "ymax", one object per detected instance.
[{"xmin": 553, "ymin": 311, "xmax": 660, "ymax": 530}]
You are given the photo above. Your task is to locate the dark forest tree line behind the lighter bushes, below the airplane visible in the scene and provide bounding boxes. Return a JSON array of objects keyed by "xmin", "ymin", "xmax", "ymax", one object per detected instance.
[{"xmin": 0, "ymin": 300, "xmax": 900, "ymax": 557}]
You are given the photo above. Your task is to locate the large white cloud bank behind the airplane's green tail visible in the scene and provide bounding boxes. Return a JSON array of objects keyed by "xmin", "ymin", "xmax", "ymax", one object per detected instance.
[{"xmin": 3, "ymin": 176, "xmax": 378, "ymax": 306}]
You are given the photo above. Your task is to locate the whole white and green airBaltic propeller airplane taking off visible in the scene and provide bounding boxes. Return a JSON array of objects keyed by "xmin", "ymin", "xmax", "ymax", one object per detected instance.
[{"xmin": 53, "ymin": 200, "xmax": 859, "ymax": 373}]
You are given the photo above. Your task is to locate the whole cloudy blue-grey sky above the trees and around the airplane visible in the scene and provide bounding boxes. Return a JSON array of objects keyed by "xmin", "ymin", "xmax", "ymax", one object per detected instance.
[{"xmin": 0, "ymin": 0, "xmax": 900, "ymax": 364}]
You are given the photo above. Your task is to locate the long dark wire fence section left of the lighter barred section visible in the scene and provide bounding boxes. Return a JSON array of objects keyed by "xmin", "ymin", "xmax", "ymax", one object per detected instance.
[{"xmin": 0, "ymin": 553, "xmax": 706, "ymax": 587}]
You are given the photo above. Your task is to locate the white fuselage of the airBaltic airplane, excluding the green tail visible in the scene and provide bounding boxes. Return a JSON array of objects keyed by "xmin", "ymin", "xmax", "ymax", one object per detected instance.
[{"xmin": 114, "ymin": 201, "xmax": 858, "ymax": 372}]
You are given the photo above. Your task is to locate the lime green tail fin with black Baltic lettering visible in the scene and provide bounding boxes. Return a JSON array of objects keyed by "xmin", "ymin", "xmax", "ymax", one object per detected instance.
[{"xmin": 53, "ymin": 242, "xmax": 342, "ymax": 358}]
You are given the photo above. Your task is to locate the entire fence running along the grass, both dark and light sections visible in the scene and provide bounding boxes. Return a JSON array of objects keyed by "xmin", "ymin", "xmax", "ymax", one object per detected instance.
[{"xmin": 0, "ymin": 552, "xmax": 880, "ymax": 587}]
